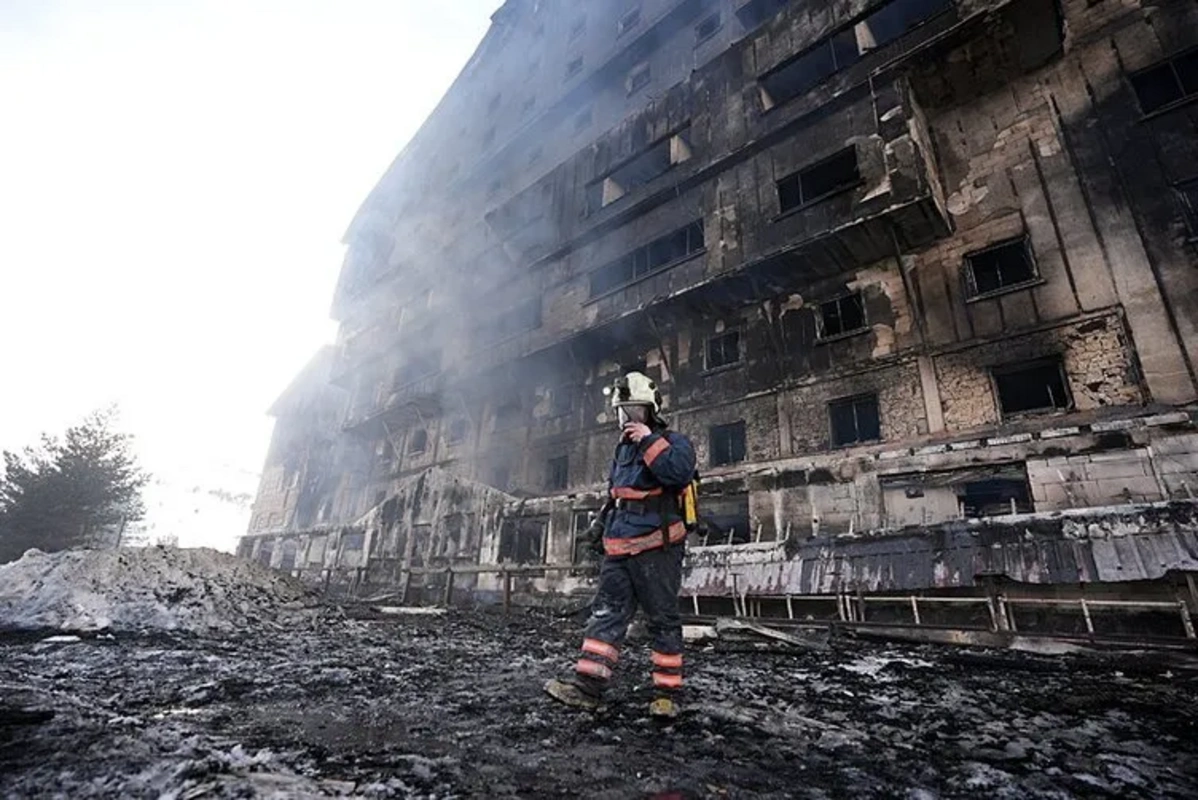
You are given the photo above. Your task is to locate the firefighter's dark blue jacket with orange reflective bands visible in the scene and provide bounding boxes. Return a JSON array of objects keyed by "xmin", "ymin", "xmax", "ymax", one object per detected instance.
[{"xmin": 604, "ymin": 429, "xmax": 695, "ymax": 556}]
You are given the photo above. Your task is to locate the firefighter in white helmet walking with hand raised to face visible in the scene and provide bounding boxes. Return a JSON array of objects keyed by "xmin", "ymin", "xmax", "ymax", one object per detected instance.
[{"xmin": 545, "ymin": 372, "xmax": 695, "ymax": 719}]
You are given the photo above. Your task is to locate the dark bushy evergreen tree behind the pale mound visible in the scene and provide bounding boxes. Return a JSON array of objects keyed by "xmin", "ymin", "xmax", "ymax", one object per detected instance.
[{"xmin": 0, "ymin": 408, "xmax": 149, "ymax": 563}]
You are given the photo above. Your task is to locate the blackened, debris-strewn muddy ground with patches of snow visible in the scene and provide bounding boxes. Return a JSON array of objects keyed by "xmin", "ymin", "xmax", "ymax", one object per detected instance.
[{"xmin": 0, "ymin": 612, "xmax": 1198, "ymax": 798}]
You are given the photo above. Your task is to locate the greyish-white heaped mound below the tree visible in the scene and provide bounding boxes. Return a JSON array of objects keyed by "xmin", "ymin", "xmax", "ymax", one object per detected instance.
[{"xmin": 0, "ymin": 547, "xmax": 314, "ymax": 634}]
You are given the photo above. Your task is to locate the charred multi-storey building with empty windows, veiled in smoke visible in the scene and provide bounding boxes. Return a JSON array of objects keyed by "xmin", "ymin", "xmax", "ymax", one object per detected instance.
[{"xmin": 243, "ymin": 0, "xmax": 1198, "ymax": 622}]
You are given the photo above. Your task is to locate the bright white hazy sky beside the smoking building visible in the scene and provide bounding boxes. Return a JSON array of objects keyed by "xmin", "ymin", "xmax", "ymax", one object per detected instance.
[{"xmin": 0, "ymin": 0, "xmax": 501, "ymax": 531}]
